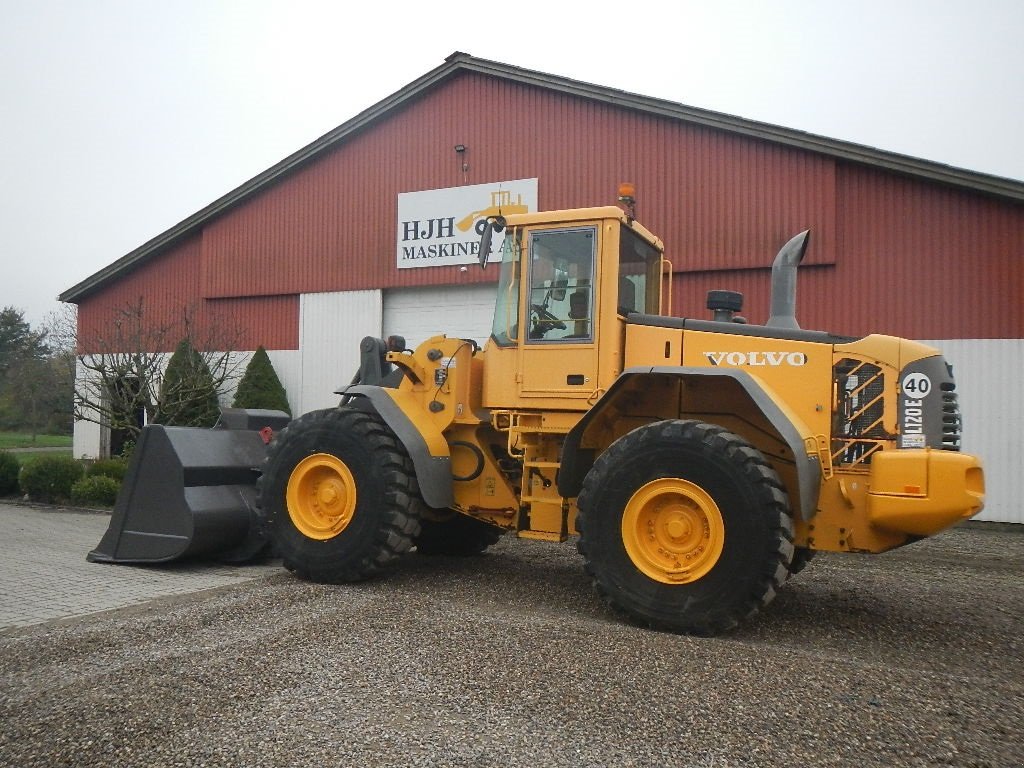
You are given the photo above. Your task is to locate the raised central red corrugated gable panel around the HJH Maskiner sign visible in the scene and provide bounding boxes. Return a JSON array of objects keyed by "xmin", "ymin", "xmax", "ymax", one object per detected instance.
[{"xmin": 203, "ymin": 75, "xmax": 835, "ymax": 296}]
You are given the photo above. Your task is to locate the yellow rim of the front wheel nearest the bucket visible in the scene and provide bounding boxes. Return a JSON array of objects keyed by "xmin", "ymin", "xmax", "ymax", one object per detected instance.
[{"xmin": 287, "ymin": 454, "xmax": 355, "ymax": 541}]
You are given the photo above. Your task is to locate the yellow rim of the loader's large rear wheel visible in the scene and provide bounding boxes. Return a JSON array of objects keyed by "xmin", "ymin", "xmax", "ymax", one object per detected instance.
[{"xmin": 623, "ymin": 477, "xmax": 725, "ymax": 584}]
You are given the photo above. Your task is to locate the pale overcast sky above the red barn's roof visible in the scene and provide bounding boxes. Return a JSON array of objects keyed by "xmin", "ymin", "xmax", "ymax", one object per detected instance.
[{"xmin": 0, "ymin": 0, "xmax": 1024, "ymax": 325}]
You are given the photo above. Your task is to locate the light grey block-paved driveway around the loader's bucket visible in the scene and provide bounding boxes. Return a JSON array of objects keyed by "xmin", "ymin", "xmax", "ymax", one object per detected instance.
[{"xmin": 0, "ymin": 504, "xmax": 280, "ymax": 632}]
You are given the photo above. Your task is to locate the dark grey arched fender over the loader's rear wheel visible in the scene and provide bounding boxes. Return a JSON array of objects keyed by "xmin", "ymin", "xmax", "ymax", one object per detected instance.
[{"xmin": 558, "ymin": 366, "xmax": 822, "ymax": 520}]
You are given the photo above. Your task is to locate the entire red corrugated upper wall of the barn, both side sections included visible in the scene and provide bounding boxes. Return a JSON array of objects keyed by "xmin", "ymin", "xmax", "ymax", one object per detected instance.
[{"xmin": 83, "ymin": 73, "xmax": 1024, "ymax": 348}]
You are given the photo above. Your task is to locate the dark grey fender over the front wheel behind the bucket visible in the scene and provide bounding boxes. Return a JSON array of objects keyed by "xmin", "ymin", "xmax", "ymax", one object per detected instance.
[{"xmin": 339, "ymin": 384, "xmax": 455, "ymax": 509}]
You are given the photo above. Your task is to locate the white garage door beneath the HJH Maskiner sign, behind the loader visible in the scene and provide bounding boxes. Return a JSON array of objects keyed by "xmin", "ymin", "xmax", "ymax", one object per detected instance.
[{"xmin": 384, "ymin": 284, "xmax": 498, "ymax": 349}]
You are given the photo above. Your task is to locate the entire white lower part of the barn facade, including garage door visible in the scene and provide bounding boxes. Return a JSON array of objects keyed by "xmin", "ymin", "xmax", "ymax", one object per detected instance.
[{"xmin": 73, "ymin": 301, "xmax": 1024, "ymax": 523}]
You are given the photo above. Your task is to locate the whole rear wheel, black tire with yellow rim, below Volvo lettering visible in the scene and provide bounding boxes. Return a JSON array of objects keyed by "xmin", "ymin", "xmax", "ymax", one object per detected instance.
[{"xmin": 577, "ymin": 420, "xmax": 793, "ymax": 635}]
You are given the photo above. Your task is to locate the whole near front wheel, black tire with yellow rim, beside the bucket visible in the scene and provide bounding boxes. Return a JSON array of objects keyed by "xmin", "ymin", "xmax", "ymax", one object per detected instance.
[{"xmin": 259, "ymin": 408, "xmax": 424, "ymax": 583}]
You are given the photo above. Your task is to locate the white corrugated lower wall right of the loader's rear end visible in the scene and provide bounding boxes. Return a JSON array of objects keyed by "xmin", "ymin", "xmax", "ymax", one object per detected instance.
[{"xmin": 924, "ymin": 339, "xmax": 1024, "ymax": 523}]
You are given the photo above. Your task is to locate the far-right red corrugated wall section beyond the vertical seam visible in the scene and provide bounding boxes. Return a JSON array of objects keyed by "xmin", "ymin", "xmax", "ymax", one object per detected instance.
[{"xmin": 831, "ymin": 165, "xmax": 1024, "ymax": 339}]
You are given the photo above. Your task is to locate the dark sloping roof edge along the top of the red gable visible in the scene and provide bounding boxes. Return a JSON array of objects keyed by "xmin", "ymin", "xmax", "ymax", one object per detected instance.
[{"xmin": 59, "ymin": 51, "xmax": 1024, "ymax": 302}]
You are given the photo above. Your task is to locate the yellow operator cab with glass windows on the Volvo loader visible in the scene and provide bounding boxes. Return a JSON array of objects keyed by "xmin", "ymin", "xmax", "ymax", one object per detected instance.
[{"xmin": 481, "ymin": 207, "xmax": 664, "ymax": 410}]
